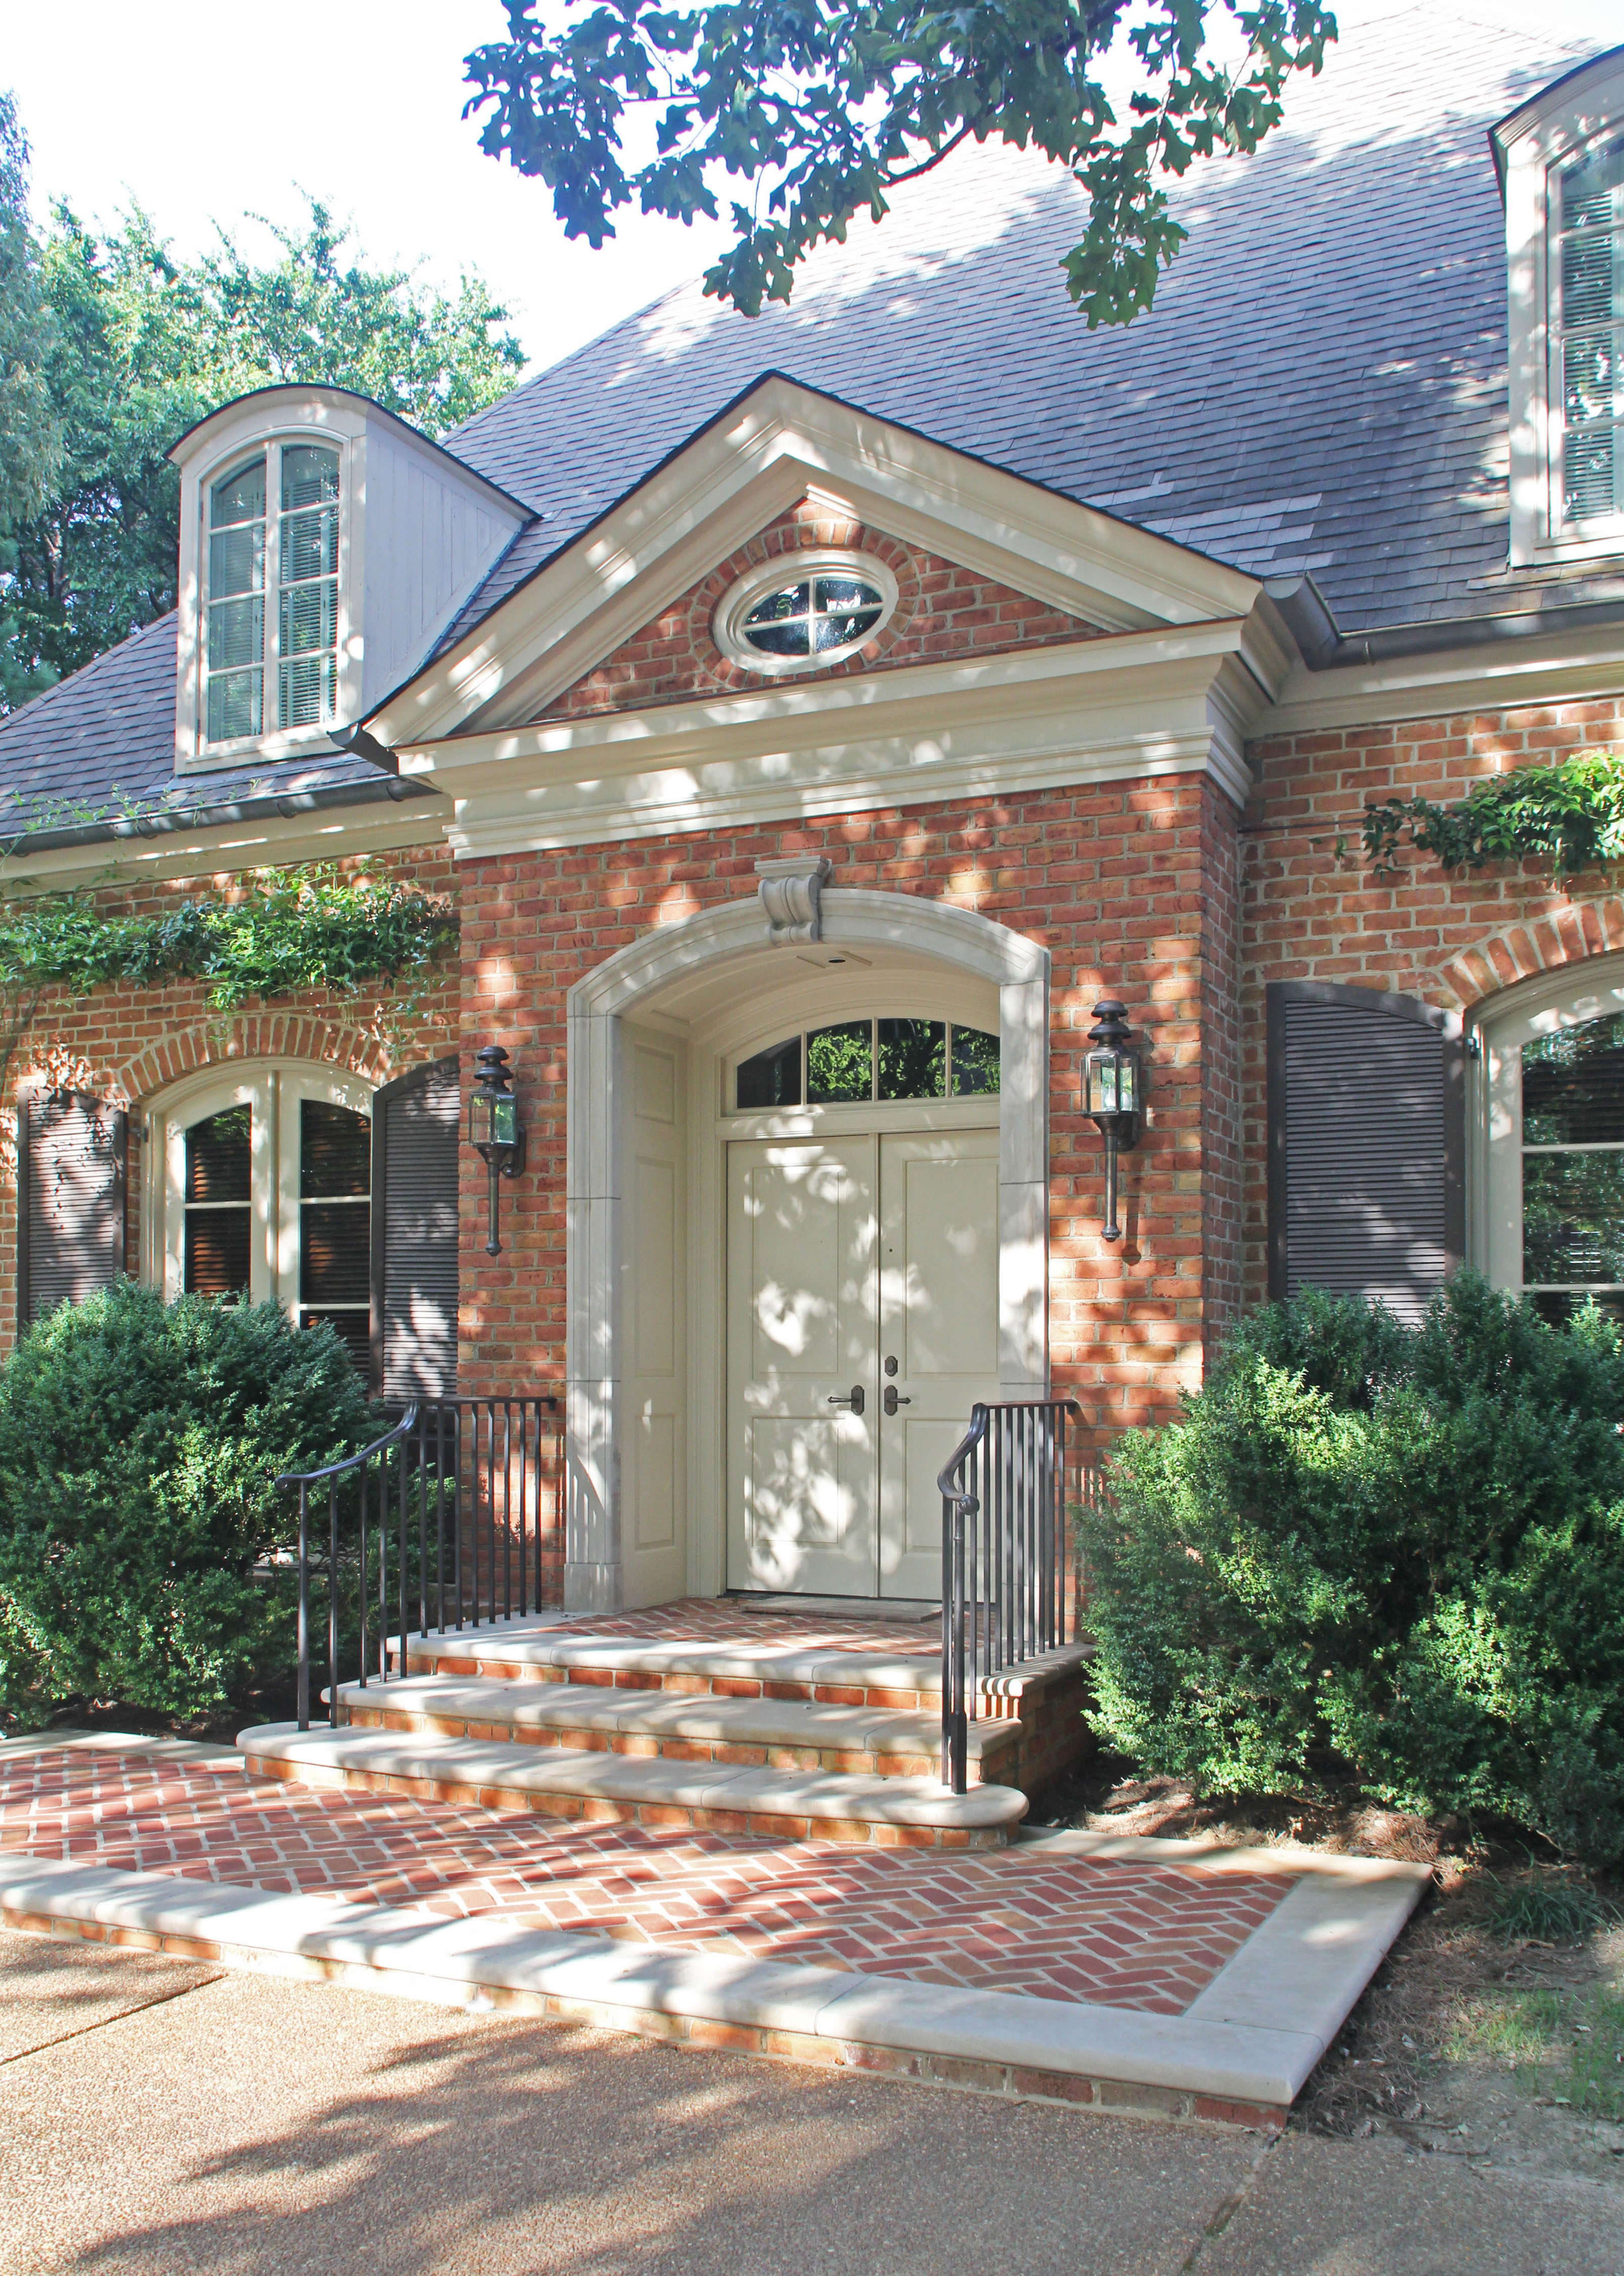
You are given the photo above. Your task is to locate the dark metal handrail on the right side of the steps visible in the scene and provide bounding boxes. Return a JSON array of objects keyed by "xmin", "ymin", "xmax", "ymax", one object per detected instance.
[{"xmin": 936, "ymin": 1400, "xmax": 1082, "ymax": 1794}]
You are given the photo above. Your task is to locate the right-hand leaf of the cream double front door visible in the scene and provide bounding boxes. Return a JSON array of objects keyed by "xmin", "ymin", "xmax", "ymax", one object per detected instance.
[{"xmin": 879, "ymin": 1131, "xmax": 998, "ymax": 1598}]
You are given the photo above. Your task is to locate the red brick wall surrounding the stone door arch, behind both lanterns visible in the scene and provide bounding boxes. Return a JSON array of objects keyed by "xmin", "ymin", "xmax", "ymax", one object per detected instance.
[{"xmin": 460, "ymin": 776, "xmax": 1235, "ymax": 1432}]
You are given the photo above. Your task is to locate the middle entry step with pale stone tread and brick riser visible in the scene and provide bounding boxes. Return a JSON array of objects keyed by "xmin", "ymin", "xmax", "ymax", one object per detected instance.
[{"xmin": 324, "ymin": 1675, "xmax": 1020, "ymax": 1785}]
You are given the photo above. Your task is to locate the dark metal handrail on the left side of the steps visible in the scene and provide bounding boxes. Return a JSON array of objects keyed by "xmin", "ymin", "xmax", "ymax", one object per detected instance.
[{"xmin": 276, "ymin": 1393, "xmax": 563, "ymax": 1730}]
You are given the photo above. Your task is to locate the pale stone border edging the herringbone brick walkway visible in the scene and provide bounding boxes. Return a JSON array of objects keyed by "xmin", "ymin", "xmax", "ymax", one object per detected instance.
[{"xmin": 0, "ymin": 1730, "xmax": 1430, "ymax": 2128}]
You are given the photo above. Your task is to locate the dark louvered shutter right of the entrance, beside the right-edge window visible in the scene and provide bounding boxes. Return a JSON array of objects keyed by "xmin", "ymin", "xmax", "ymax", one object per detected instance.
[{"xmin": 1269, "ymin": 981, "xmax": 1465, "ymax": 1320}]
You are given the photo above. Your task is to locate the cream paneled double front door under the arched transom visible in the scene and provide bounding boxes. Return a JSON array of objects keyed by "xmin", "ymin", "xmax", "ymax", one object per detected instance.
[{"xmin": 727, "ymin": 1129, "xmax": 998, "ymax": 1600}]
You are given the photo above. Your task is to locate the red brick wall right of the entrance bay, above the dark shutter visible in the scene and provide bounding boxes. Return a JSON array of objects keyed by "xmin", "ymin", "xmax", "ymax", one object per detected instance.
[{"xmin": 1241, "ymin": 699, "xmax": 1624, "ymax": 1304}]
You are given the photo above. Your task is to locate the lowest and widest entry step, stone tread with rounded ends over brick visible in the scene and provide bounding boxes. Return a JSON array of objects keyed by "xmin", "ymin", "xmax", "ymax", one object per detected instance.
[{"xmin": 237, "ymin": 1723, "xmax": 1027, "ymax": 1848}]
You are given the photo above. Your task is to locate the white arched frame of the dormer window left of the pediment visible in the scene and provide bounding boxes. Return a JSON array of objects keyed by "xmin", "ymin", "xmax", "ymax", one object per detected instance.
[{"xmin": 175, "ymin": 391, "xmax": 367, "ymax": 774}]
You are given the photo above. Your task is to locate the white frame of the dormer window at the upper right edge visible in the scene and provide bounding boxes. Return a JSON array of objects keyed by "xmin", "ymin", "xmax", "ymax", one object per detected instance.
[{"xmin": 1494, "ymin": 48, "xmax": 1624, "ymax": 569}]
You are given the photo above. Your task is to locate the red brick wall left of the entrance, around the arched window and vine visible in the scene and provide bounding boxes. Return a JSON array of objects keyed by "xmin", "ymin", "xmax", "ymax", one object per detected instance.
[{"xmin": 0, "ymin": 849, "xmax": 458, "ymax": 1352}]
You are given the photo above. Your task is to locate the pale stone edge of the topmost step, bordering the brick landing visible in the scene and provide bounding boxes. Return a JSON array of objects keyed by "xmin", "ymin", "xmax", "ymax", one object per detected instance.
[{"xmin": 405, "ymin": 1620, "xmax": 1091, "ymax": 1696}]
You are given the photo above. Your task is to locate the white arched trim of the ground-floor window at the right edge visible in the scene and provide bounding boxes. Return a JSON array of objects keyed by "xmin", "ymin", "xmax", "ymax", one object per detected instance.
[{"xmin": 1467, "ymin": 956, "xmax": 1624, "ymax": 1291}]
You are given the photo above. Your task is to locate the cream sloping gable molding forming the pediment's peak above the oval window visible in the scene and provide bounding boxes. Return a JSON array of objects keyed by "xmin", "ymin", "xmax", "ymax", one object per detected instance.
[{"xmin": 371, "ymin": 378, "xmax": 1259, "ymax": 749}]
